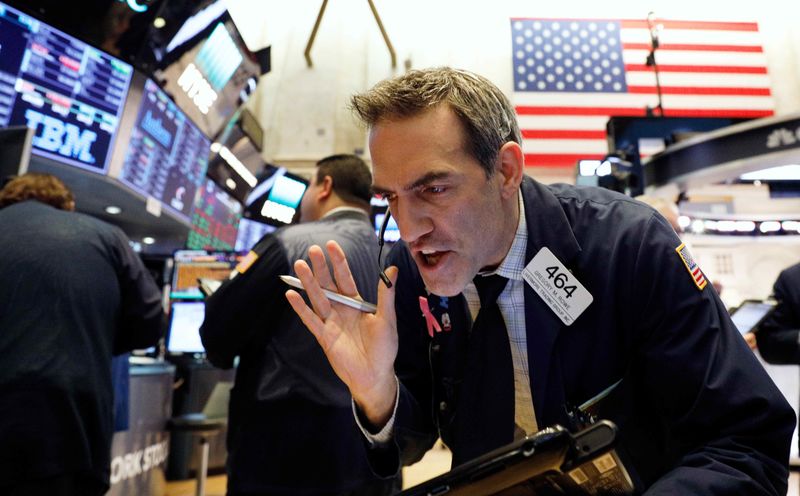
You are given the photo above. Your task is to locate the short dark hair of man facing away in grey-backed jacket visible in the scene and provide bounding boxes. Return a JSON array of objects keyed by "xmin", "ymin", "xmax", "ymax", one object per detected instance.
[{"xmin": 317, "ymin": 154, "xmax": 372, "ymax": 209}]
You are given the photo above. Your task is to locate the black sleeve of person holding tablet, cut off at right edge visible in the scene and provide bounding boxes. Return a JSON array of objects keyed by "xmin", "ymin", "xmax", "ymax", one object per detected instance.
[{"xmin": 756, "ymin": 266, "xmax": 800, "ymax": 365}]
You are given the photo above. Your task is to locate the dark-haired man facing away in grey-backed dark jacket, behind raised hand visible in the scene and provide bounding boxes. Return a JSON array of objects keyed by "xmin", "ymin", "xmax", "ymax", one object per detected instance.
[{"xmin": 200, "ymin": 155, "xmax": 393, "ymax": 496}]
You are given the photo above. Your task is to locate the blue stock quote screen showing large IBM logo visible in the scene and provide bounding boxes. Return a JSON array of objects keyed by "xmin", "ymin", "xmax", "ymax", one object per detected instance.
[{"xmin": 0, "ymin": 3, "xmax": 133, "ymax": 173}]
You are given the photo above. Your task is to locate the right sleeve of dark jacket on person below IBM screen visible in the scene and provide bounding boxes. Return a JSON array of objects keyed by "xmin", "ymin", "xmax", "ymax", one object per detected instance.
[{"xmin": 113, "ymin": 229, "xmax": 164, "ymax": 355}]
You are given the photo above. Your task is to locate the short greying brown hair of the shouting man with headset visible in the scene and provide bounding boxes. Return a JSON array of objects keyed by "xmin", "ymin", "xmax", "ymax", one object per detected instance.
[{"xmin": 350, "ymin": 67, "xmax": 522, "ymax": 177}]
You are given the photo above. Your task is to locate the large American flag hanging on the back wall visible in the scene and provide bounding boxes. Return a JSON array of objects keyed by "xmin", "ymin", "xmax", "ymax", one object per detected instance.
[{"xmin": 511, "ymin": 18, "xmax": 774, "ymax": 167}]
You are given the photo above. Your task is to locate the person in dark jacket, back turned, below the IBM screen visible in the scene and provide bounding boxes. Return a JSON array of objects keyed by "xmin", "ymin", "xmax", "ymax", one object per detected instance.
[{"xmin": 0, "ymin": 174, "xmax": 163, "ymax": 496}]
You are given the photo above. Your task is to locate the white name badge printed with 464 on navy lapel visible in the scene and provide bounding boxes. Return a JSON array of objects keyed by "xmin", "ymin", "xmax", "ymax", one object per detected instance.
[{"xmin": 522, "ymin": 247, "xmax": 594, "ymax": 325}]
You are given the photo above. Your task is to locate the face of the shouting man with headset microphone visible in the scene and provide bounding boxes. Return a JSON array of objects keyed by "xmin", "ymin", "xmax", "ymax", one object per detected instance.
[{"xmin": 369, "ymin": 105, "xmax": 517, "ymax": 296}]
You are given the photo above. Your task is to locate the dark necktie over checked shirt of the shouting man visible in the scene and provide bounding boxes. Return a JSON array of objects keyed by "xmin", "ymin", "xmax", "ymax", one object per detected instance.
[{"xmin": 446, "ymin": 275, "xmax": 514, "ymax": 461}]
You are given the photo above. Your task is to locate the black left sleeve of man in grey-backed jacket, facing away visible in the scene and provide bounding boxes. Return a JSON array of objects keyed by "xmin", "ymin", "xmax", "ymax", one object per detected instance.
[{"xmin": 200, "ymin": 235, "xmax": 292, "ymax": 368}]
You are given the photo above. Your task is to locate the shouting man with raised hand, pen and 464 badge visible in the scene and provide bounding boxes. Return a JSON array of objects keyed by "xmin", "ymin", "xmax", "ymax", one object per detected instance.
[{"xmin": 286, "ymin": 68, "xmax": 793, "ymax": 495}]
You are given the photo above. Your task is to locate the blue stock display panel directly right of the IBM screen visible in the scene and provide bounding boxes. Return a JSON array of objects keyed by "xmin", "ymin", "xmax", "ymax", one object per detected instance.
[{"xmin": 119, "ymin": 79, "xmax": 211, "ymax": 220}]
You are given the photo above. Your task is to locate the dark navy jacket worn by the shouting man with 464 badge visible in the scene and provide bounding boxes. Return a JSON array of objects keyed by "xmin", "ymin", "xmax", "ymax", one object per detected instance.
[{"xmin": 382, "ymin": 177, "xmax": 794, "ymax": 495}]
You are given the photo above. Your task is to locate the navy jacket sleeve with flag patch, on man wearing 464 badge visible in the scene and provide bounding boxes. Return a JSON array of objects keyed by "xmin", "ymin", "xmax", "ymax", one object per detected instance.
[{"xmin": 631, "ymin": 216, "xmax": 795, "ymax": 496}]
